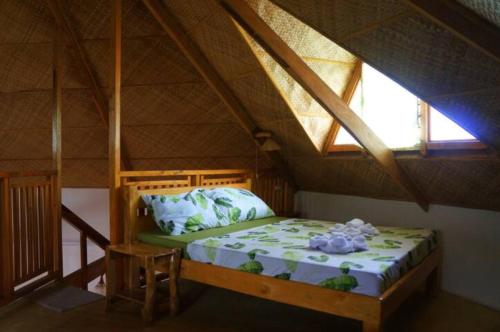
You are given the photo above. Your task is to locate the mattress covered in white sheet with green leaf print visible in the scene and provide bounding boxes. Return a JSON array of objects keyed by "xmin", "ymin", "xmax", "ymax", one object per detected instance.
[{"xmin": 186, "ymin": 218, "xmax": 437, "ymax": 296}]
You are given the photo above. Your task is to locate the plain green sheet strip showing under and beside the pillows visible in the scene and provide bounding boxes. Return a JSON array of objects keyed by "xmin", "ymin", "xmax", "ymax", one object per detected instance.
[{"xmin": 138, "ymin": 217, "xmax": 287, "ymax": 251}]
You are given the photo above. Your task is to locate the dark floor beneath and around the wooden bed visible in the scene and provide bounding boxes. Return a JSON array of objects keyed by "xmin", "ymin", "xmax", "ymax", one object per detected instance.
[{"xmin": 0, "ymin": 284, "xmax": 500, "ymax": 332}]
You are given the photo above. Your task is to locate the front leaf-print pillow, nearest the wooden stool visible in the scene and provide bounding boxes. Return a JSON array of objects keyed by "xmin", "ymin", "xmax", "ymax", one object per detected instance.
[{"xmin": 142, "ymin": 189, "xmax": 230, "ymax": 235}]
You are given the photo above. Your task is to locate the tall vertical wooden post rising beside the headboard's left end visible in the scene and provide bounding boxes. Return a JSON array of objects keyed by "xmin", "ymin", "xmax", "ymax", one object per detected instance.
[{"xmin": 108, "ymin": 0, "xmax": 122, "ymax": 244}]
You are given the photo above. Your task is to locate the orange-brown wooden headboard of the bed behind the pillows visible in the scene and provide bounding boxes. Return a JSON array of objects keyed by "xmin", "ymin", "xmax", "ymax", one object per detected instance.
[{"xmin": 122, "ymin": 170, "xmax": 252, "ymax": 243}]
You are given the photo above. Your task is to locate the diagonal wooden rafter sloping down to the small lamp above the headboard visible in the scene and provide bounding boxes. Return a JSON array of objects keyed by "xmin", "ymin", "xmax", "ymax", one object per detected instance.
[{"xmin": 143, "ymin": 0, "xmax": 295, "ymax": 186}]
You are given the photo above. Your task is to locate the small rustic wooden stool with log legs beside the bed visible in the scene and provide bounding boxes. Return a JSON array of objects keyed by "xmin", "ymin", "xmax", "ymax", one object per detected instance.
[{"xmin": 106, "ymin": 244, "xmax": 181, "ymax": 322}]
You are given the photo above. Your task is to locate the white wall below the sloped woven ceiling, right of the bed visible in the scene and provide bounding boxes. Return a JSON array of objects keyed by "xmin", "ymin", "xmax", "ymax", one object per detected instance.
[{"xmin": 296, "ymin": 191, "xmax": 500, "ymax": 309}]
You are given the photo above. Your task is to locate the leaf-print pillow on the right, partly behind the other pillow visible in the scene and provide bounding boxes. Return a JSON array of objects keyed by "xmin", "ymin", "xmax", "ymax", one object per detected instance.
[{"xmin": 206, "ymin": 188, "xmax": 275, "ymax": 224}]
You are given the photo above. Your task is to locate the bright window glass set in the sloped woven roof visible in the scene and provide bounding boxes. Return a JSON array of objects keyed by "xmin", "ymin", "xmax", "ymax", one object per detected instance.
[{"xmin": 331, "ymin": 64, "xmax": 482, "ymax": 151}]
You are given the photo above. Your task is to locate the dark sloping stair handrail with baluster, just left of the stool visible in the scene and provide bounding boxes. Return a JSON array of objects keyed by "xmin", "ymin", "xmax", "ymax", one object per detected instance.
[{"xmin": 61, "ymin": 205, "xmax": 109, "ymax": 289}]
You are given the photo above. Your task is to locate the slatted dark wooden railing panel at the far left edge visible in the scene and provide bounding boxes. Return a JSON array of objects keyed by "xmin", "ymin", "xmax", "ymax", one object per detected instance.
[{"xmin": 0, "ymin": 171, "xmax": 62, "ymax": 303}]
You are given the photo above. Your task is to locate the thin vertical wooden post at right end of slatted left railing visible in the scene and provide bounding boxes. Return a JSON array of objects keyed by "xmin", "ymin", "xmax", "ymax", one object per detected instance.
[{"xmin": 52, "ymin": 24, "xmax": 63, "ymax": 279}]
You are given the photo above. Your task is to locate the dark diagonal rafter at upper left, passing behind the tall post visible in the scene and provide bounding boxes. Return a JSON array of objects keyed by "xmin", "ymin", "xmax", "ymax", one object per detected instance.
[{"xmin": 46, "ymin": 0, "xmax": 132, "ymax": 169}]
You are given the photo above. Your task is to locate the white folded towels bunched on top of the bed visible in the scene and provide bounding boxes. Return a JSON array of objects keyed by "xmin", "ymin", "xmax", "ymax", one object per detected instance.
[{"xmin": 309, "ymin": 219, "xmax": 380, "ymax": 254}]
